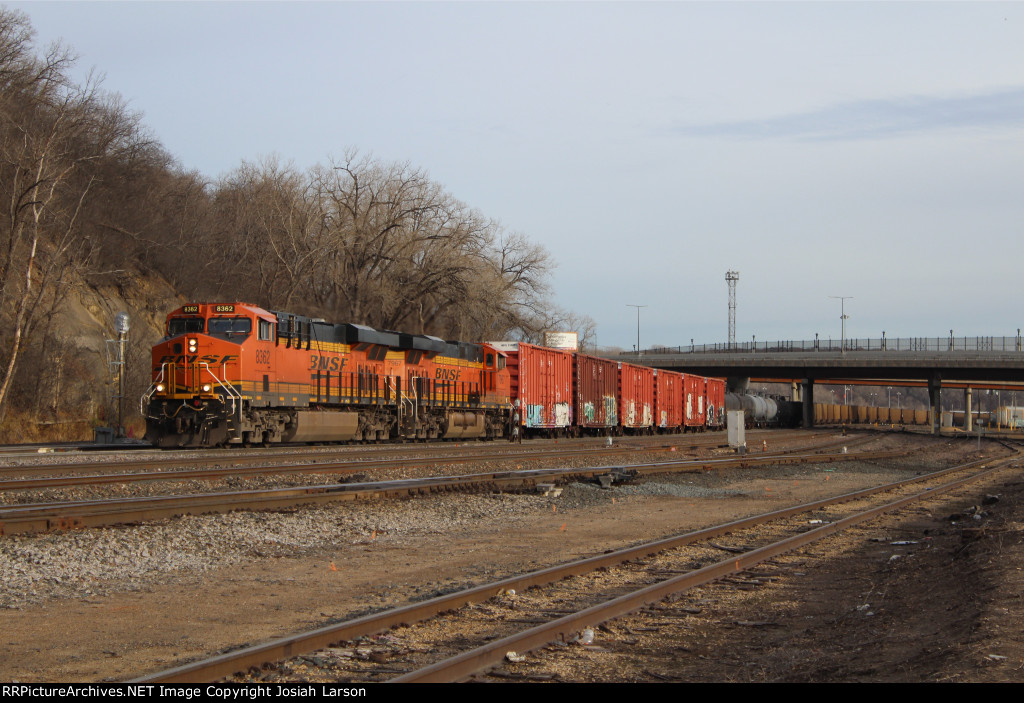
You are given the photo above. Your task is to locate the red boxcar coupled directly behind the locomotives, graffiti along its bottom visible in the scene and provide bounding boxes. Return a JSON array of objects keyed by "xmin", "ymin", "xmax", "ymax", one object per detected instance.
[{"xmin": 502, "ymin": 343, "xmax": 572, "ymax": 434}]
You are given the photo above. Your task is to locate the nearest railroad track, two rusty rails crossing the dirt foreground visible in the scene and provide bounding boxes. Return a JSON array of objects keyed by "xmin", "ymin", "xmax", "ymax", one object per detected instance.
[{"xmin": 136, "ymin": 453, "xmax": 1020, "ymax": 683}]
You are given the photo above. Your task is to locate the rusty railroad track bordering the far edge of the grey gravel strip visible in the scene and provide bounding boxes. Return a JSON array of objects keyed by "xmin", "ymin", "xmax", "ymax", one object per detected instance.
[{"xmin": 0, "ymin": 437, "xmax": 888, "ymax": 535}]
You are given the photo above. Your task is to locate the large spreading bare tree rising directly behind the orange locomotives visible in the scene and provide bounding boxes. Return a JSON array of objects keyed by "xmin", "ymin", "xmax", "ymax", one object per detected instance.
[{"xmin": 303, "ymin": 152, "xmax": 550, "ymax": 339}]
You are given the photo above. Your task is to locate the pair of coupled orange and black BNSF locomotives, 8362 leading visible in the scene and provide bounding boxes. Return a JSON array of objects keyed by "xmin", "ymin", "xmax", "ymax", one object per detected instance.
[{"xmin": 142, "ymin": 303, "xmax": 511, "ymax": 447}]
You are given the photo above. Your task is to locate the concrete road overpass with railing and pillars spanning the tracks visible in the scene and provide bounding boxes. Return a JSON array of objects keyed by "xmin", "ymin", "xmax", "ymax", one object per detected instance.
[{"xmin": 618, "ymin": 331, "xmax": 1024, "ymax": 434}]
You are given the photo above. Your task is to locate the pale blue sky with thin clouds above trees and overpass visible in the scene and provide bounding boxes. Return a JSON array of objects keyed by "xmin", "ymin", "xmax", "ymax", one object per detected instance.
[{"xmin": 8, "ymin": 2, "xmax": 1024, "ymax": 348}]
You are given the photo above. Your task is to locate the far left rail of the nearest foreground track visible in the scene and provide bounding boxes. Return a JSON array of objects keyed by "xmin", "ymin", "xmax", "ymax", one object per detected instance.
[{"xmin": 128, "ymin": 448, "xmax": 999, "ymax": 683}]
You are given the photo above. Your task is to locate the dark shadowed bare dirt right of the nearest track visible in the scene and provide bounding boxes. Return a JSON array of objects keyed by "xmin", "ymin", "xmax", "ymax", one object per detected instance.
[{"xmin": 501, "ymin": 466, "xmax": 1024, "ymax": 683}]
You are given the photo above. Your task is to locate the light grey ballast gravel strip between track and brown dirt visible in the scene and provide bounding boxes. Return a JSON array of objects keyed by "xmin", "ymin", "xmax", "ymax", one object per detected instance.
[{"xmin": 0, "ymin": 482, "xmax": 741, "ymax": 608}]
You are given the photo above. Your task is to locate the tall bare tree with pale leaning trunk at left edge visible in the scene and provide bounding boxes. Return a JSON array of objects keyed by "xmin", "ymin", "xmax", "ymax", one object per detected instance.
[{"xmin": 0, "ymin": 10, "xmax": 149, "ymax": 412}]
